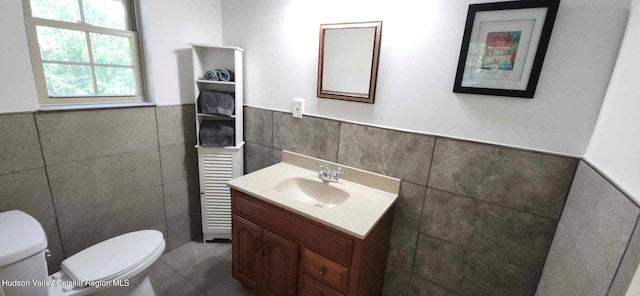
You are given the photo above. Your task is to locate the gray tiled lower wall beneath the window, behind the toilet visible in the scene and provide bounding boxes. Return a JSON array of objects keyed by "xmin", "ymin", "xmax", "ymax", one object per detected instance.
[{"xmin": 0, "ymin": 105, "xmax": 201, "ymax": 271}]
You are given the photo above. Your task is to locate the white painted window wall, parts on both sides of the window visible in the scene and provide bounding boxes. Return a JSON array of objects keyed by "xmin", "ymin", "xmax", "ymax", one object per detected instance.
[{"xmin": 0, "ymin": 0, "xmax": 222, "ymax": 113}]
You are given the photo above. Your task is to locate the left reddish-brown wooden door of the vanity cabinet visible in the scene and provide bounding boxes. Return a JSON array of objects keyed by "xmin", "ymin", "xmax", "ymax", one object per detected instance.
[{"xmin": 232, "ymin": 215, "xmax": 262, "ymax": 293}]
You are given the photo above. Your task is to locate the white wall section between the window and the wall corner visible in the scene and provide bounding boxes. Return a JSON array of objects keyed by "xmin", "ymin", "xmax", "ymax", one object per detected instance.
[{"xmin": 139, "ymin": 0, "xmax": 222, "ymax": 105}]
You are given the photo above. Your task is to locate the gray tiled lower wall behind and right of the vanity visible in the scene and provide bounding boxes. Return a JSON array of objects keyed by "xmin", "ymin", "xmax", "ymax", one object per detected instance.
[{"xmin": 244, "ymin": 107, "xmax": 578, "ymax": 296}]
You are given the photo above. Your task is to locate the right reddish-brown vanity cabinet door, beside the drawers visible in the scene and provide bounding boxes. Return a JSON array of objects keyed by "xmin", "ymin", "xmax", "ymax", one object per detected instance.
[{"xmin": 262, "ymin": 230, "xmax": 298, "ymax": 296}]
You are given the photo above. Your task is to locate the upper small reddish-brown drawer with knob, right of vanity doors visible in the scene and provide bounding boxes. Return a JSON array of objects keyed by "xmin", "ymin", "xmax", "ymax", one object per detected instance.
[{"xmin": 301, "ymin": 249, "xmax": 349, "ymax": 293}]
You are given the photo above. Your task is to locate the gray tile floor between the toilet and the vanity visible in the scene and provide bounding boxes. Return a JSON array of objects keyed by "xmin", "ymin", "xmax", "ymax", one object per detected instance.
[{"xmin": 149, "ymin": 240, "xmax": 252, "ymax": 296}]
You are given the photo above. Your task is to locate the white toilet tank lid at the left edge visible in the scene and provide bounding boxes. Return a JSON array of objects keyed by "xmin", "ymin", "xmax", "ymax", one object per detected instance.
[{"xmin": 0, "ymin": 210, "xmax": 47, "ymax": 267}]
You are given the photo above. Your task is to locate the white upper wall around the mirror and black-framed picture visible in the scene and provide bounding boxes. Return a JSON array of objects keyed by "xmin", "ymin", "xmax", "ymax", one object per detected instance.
[{"xmin": 222, "ymin": 0, "xmax": 629, "ymax": 156}]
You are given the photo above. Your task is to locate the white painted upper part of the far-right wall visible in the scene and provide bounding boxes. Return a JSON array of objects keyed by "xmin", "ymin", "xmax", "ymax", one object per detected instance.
[{"xmin": 585, "ymin": 0, "xmax": 640, "ymax": 202}]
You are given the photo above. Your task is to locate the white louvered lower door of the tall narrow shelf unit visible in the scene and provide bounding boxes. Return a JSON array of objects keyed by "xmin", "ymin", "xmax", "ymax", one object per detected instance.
[{"xmin": 198, "ymin": 143, "xmax": 244, "ymax": 241}]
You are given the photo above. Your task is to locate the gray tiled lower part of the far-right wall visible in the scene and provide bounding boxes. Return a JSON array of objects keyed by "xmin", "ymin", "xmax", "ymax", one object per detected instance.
[{"xmin": 536, "ymin": 162, "xmax": 640, "ymax": 296}]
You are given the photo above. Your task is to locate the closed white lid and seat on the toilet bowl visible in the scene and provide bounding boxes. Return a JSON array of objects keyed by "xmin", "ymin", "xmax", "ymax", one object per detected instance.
[{"xmin": 61, "ymin": 230, "xmax": 165, "ymax": 281}]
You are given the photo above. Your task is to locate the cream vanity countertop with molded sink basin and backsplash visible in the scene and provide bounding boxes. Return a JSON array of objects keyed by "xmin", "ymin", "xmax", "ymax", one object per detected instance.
[{"xmin": 227, "ymin": 150, "xmax": 400, "ymax": 239}]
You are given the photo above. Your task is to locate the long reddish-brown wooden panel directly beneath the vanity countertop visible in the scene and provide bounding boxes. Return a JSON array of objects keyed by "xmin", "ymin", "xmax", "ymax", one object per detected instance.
[{"xmin": 231, "ymin": 189, "xmax": 354, "ymax": 266}]
